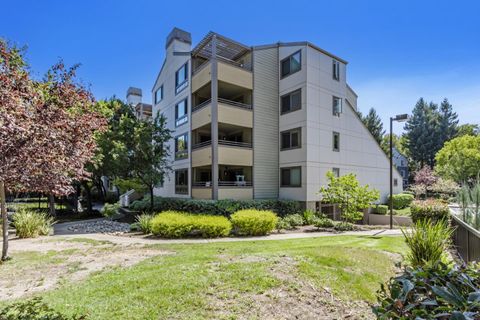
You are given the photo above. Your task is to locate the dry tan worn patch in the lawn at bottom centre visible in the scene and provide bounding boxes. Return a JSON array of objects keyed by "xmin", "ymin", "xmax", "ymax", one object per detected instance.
[{"xmin": 210, "ymin": 256, "xmax": 373, "ymax": 320}]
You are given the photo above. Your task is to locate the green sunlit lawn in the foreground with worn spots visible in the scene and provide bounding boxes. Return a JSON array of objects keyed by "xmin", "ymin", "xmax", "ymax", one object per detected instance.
[{"xmin": 33, "ymin": 236, "xmax": 406, "ymax": 319}]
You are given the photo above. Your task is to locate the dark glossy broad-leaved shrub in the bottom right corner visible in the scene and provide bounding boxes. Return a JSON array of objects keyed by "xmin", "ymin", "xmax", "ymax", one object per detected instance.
[{"xmin": 373, "ymin": 263, "xmax": 480, "ymax": 320}]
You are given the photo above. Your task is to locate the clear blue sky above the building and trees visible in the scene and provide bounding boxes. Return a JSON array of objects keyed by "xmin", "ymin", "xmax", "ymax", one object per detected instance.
[{"xmin": 0, "ymin": 0, "xmax": 480, "ymax": 130}]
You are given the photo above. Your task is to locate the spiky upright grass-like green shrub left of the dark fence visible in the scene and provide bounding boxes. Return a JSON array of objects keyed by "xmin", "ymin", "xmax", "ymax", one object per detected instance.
[{"xmin": 402, "ymin": 219, "xmax": 453, "ymax": 268}]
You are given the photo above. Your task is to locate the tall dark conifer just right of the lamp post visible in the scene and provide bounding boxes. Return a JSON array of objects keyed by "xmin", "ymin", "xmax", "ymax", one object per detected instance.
[{"xmin": 405, "ymin": 98, "xmax": 440, "ymax": 168}]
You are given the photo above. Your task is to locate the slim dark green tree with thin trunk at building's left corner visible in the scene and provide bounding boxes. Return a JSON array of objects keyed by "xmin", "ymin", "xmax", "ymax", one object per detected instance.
[{"xmin": 128, "ymin": 114, "xmax": 172, "ymax": 211}]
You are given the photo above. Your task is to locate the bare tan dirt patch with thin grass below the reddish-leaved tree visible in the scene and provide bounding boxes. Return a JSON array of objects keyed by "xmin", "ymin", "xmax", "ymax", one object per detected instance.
[{"xmin": 0, "ymin": 238, "xmax": 173, "ymax": 300}]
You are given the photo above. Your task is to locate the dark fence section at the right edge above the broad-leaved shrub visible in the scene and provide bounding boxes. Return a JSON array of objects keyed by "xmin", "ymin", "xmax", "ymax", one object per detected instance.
[{"xmin": 451, "ymin": 213, "xmax": 480, "ymax": 262}]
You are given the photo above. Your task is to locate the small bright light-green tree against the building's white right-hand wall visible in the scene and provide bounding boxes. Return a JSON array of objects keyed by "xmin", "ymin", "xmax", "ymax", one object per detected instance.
[{"xmin": 318, "ymin": 171, "xmax": 380, "ymax": 222}]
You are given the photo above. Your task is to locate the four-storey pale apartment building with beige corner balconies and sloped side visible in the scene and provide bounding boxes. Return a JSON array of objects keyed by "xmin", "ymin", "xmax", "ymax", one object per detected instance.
[{"xmin": 152, "ymin": 28, "xmax": 402, "ymax": 208}]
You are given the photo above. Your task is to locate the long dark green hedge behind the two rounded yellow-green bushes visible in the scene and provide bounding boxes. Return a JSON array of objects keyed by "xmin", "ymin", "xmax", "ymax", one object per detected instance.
[{"xmin": 130, "ymin": 197, "xmax": 303, "ymax": 217}]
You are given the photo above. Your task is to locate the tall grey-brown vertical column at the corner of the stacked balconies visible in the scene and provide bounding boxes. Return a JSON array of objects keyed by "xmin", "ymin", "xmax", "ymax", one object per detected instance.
[{"xmin": 210, "ymin": 35, "xmax": 219, "ymax": 200}]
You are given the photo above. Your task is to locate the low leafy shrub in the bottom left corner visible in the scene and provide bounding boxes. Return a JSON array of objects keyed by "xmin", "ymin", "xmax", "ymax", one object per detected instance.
[{"xmin": 0, "ymin": 298, "xmax": 86, "ymax": 320}]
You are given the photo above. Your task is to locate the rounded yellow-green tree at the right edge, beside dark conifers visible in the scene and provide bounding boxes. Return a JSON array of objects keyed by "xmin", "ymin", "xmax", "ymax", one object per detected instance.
[{"xmin": 435, "ymin": 135, "xmax": 480, "ymax": 183}]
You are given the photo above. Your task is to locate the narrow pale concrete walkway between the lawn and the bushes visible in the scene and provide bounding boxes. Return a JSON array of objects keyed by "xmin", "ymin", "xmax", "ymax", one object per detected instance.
[{"xmin": 54, "ymin": 229, "xmax": 402, "ymax": 245}]
